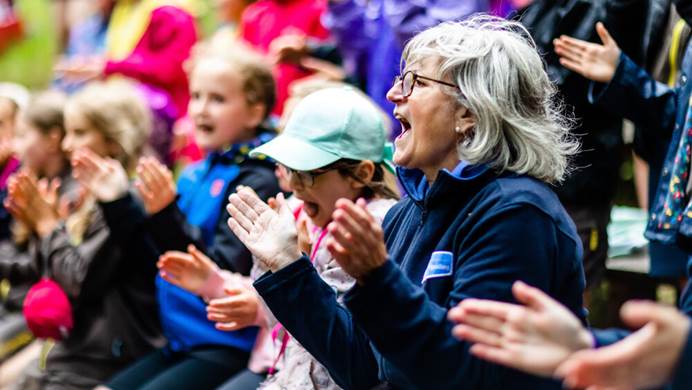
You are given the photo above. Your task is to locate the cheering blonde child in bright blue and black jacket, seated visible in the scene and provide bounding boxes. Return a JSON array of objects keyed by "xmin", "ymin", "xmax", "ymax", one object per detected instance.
[{"xmin": 101, "ymin": 42, "xmax": 279, "ymax": 389}]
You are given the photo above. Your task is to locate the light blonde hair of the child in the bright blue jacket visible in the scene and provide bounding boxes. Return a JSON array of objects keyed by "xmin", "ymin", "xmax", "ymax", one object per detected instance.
[{"xmin": 186, "ymin": 42, "xmax": 276, "ymax": 119}]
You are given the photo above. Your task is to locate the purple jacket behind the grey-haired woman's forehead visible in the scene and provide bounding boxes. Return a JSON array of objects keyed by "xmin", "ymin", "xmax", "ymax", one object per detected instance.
[{"xmin": 324, "ymin": 0, "xmax": 489, "ymax": 137}]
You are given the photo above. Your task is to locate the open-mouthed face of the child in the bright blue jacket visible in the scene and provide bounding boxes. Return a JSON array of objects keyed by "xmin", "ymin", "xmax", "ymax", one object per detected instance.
[{"xmin": 189, "ymin": 59, "xmax": 261, "ymax": 150}]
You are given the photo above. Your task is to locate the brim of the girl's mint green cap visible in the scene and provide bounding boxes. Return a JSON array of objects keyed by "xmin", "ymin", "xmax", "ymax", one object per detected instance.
[{"xmin": 250, "ymin": 134, "xmax": 339, "ymax": 171}]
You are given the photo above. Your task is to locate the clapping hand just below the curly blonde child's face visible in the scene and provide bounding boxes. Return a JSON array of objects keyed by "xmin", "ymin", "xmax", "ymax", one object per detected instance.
[{"xmin": 72, "ymin": 149, "xmax": 129, "ymax": 202}]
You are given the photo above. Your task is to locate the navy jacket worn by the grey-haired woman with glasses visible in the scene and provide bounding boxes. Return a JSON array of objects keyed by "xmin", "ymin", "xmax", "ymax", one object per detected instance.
[{"xmin": 255, "ymin": 162, "xmax": 584, "ymax": 390}]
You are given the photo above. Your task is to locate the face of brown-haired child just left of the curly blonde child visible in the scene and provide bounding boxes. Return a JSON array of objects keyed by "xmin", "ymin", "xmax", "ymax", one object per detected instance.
[{"xmin": 12, "ymin": 117, "xmax": 58, "ymax": 174}]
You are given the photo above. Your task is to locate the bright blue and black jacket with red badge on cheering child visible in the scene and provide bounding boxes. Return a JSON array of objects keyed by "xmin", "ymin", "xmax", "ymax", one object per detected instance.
[{"xmin": 147, "ymin": 132, "xmax": 280, "ymax": 351}]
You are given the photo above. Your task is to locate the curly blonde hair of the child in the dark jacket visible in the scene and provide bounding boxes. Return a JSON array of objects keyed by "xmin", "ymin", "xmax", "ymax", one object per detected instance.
[{"xmin": 67, "ymin": 80, "xmax": 152, "ymax": 170}]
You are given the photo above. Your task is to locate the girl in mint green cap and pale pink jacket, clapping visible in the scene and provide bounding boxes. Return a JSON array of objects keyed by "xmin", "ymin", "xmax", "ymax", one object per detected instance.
[{"xmin": 162, "ymin": 87, "xmax": 398, "ymax": 389}]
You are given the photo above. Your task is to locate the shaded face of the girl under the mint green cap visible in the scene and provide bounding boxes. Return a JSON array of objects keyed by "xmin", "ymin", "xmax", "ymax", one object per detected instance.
[{"xmin": 288, "ymin": 170, "xmax": 362, "ymax": 228}]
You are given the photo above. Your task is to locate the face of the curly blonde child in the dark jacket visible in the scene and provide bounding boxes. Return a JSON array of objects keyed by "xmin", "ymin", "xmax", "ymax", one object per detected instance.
[{"xmin": 62, "ymin": 105, "xmax": 113, "ymax": 157}]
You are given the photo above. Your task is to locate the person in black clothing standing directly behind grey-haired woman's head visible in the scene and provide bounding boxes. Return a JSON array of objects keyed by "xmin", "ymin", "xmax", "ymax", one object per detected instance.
[{"xmin": 515, "ymin": 0, "xmax": 648, "ymax": 298}]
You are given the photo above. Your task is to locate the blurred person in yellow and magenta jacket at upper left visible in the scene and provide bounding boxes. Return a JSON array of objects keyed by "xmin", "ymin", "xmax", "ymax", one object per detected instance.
[{"xmin": 56, "ymin": 0, "xmax": 197, "ymax": 164}]
